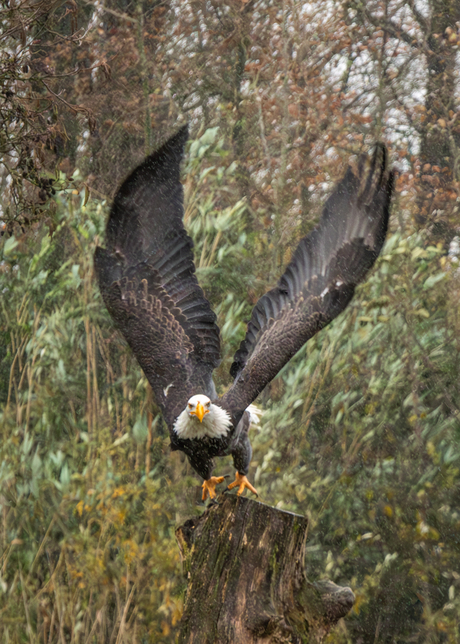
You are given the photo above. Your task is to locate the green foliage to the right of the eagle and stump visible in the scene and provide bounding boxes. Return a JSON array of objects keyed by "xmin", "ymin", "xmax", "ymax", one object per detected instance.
[{"xmin": 254, "ymin": 233, "xmax": 460, "ymax": 643}]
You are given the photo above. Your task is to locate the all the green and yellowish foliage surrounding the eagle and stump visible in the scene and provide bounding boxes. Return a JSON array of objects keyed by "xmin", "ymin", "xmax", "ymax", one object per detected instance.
[{"xmin": 0, "ymin": 130, "xmax": 460, "ymax": 644}]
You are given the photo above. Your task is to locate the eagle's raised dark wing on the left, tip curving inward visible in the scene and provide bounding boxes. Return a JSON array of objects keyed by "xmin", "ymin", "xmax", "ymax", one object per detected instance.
[{"xmin": 95, "ymin": 127, "xmax": 220, "ymax": 425}]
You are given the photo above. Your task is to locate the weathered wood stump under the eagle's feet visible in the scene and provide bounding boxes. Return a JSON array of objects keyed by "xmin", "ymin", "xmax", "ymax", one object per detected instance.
[{"xmin": 176, "ymin": 495, "xmax": 354, "ymax": 644}]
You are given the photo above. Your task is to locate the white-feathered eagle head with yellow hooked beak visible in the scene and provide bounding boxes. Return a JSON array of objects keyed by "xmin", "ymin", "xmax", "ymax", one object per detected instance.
[{"xmin": 174, "ymin": 394, "xmax": 232, "ymax": 438}]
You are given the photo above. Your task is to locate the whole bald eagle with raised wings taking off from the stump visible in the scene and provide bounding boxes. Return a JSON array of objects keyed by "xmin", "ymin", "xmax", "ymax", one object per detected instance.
[{"xmin": 95, "ymin": 126, "xmax": 394, "ymax": 500}]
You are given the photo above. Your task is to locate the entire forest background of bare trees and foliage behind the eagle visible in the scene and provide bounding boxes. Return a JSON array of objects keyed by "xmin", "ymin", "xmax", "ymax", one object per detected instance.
[{"xmin": 0, "ymin": 0, "xmax": 460, "ymax": 644}]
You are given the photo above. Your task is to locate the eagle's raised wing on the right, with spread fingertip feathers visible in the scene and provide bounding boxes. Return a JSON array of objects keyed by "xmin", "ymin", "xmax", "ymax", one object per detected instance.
[{"xmin": 219, "ymin": 144, "xmax": 394, "ymax": 422}]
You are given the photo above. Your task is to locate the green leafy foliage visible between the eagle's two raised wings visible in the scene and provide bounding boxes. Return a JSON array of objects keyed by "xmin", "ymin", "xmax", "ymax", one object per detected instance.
[{"xmin": 184, "ymin": 128, "xmax": 257, "ymax": 384}]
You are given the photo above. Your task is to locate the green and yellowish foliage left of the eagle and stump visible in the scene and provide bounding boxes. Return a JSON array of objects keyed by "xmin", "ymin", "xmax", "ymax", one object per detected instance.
[{"xmin": 0, "ymin": 195, "xmax": 190, "ymax": 643}]
